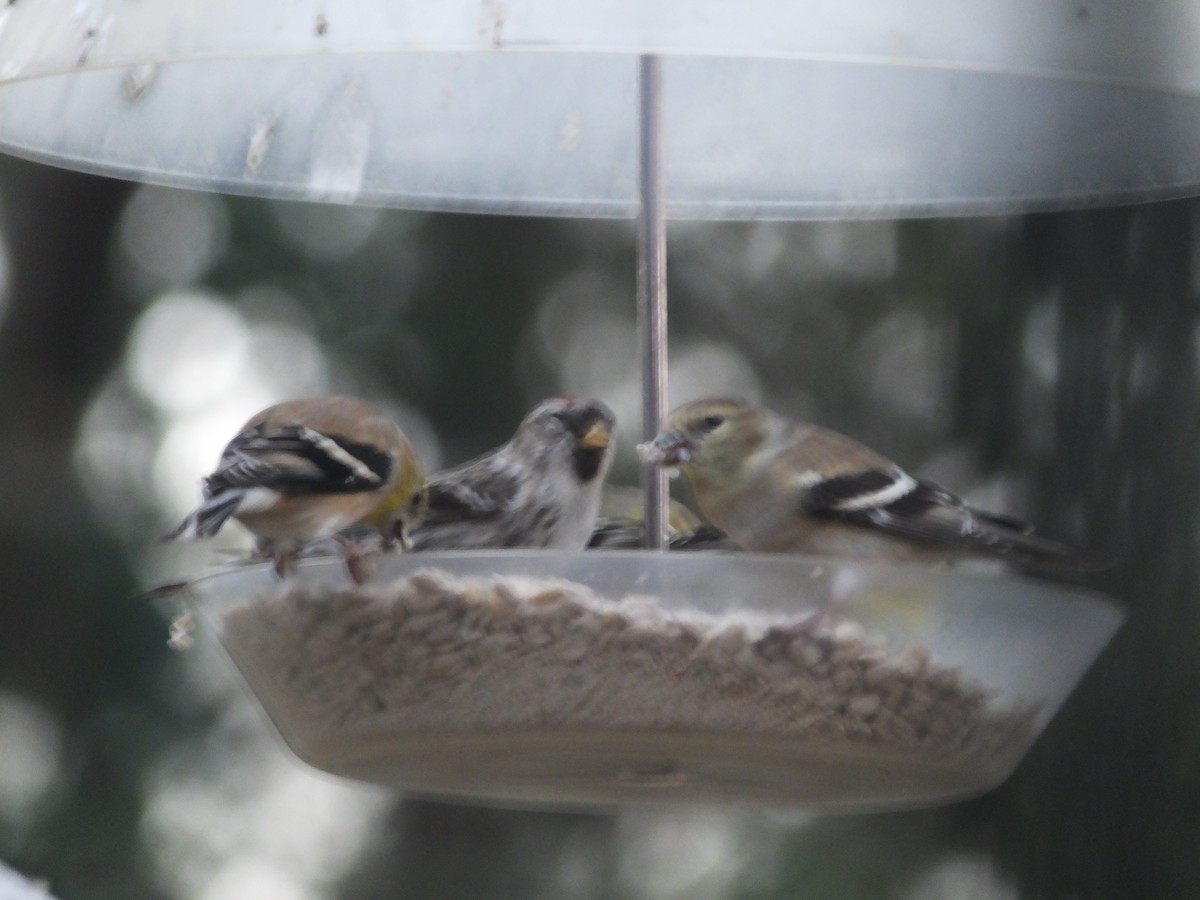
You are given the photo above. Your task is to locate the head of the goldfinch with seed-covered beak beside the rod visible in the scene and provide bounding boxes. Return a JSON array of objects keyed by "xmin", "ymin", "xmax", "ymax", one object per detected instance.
[{"xmin": 637, "ymin": 397, "xmax": 769, "ymax": 487}]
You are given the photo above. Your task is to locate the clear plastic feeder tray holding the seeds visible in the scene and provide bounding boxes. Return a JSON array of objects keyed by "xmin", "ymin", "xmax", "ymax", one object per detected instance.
[{"xmin": 182, "ymin": 552, "xmax": 1122, "ymax": 810}]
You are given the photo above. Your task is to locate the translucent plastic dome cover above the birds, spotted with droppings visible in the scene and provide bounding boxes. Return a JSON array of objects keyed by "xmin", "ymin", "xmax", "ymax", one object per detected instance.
[{"xmin": 7, "ymin": 0, "xmax": 1200, "ymax": 217}]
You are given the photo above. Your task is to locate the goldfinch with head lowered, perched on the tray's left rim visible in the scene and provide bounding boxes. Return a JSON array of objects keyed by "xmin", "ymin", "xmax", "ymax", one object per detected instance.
[{"xmin": 164, "ymin": 396, "xmax": 425, "ymax": 581}]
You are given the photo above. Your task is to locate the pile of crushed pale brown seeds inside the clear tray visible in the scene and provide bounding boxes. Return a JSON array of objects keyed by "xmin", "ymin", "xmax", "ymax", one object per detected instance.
[{"xmin": 223, "ymin": 569, "xmax": 1036, "ymax": 764}]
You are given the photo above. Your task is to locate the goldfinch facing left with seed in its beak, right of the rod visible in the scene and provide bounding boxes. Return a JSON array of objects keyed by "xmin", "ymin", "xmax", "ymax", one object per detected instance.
[{"xmin": 638, "ymin": 397, "xmax": 1074, "ymax": 562}]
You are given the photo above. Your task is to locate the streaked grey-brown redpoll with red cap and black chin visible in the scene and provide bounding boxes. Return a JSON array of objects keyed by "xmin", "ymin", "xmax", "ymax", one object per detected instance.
[{"xmin": 413, "ymin": 397, "xmax": 616, "ymax": 550}]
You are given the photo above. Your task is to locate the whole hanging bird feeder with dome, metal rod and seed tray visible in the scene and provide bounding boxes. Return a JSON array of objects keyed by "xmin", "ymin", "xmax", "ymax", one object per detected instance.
[{"xmin": 0, "ymin": 0, "xmax": 1152, "ymax": 809}]
